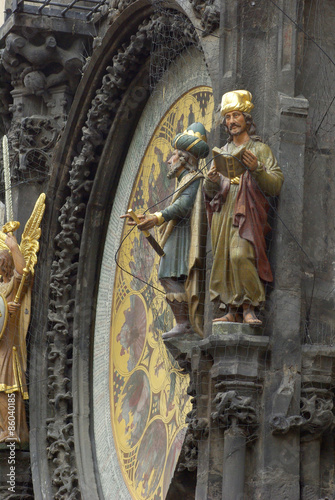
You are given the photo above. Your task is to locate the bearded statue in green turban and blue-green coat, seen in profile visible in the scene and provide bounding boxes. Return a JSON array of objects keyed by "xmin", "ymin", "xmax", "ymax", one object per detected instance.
[{"xmin": 122, "ymin": 123, "xmax": 209, "ymax": 339}]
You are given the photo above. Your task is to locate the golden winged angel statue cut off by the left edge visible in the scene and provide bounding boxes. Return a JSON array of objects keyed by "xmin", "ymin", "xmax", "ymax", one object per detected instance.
[{"xmin": 0, "ymin": 193, "xmax": 45, "ymax": 448}]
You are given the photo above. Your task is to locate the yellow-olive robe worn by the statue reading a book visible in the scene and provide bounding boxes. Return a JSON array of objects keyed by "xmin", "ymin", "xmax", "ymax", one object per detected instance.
[{"xmin": 204, "ymin": 140, "xmax": 284, "ymax": 307}]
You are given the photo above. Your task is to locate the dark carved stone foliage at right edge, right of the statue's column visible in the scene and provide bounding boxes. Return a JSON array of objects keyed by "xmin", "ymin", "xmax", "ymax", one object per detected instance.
[{"xmin": 271, "ymin": 394, "xmax": 335, "ymax": 437}]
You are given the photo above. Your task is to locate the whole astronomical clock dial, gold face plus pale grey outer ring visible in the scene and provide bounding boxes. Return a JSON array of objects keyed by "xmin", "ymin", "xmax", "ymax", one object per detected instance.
[{"xmin": 94, "ymin": 51, "xmax": 214, "ymax": 500}]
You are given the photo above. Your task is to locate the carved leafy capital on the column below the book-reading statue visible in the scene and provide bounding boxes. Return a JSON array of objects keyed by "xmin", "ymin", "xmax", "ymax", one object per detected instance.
[{"xmin": 211, "ymin": 384, "xmax": 258, "ymax": 431}]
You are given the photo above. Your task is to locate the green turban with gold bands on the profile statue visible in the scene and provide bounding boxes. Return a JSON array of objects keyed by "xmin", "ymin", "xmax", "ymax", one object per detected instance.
[{"xmin": 172, "ymin": 122, "xmax": 209, "ymax": 158}]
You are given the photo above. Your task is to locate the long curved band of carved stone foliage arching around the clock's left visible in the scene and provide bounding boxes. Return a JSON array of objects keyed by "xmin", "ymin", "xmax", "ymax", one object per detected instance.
[{"xmin": 47, "ymin": 10, "xmax": 200, "ymax": 499}]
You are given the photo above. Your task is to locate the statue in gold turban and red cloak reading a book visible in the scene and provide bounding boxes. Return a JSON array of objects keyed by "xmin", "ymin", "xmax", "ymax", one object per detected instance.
[{"xmin": 204, "ymin": 90, "xmax": 284, "ymax": 325}]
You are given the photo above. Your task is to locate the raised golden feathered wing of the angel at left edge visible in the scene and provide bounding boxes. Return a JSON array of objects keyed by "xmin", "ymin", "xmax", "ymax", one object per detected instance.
[{"xmin": 19, "ymin": 193, "xmax": 45, "ymax": 273}]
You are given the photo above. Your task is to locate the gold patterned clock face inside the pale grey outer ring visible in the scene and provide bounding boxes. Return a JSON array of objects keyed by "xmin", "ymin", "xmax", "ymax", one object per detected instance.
[{"xmin": 109, "ymin": 86, "xmax": 214, "ymax": 500}]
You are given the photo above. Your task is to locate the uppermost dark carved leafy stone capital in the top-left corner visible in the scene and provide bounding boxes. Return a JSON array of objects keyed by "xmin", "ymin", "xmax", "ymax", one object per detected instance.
[{"xmin": 2, "ymin": 33, "xmax": 84, "ymax": 92}]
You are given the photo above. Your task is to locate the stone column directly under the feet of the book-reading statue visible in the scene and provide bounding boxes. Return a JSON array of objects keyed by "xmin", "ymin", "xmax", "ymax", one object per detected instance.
[{"xmin": 196, "ymin": 323, "xmax": 269, "ymax": 500}]
